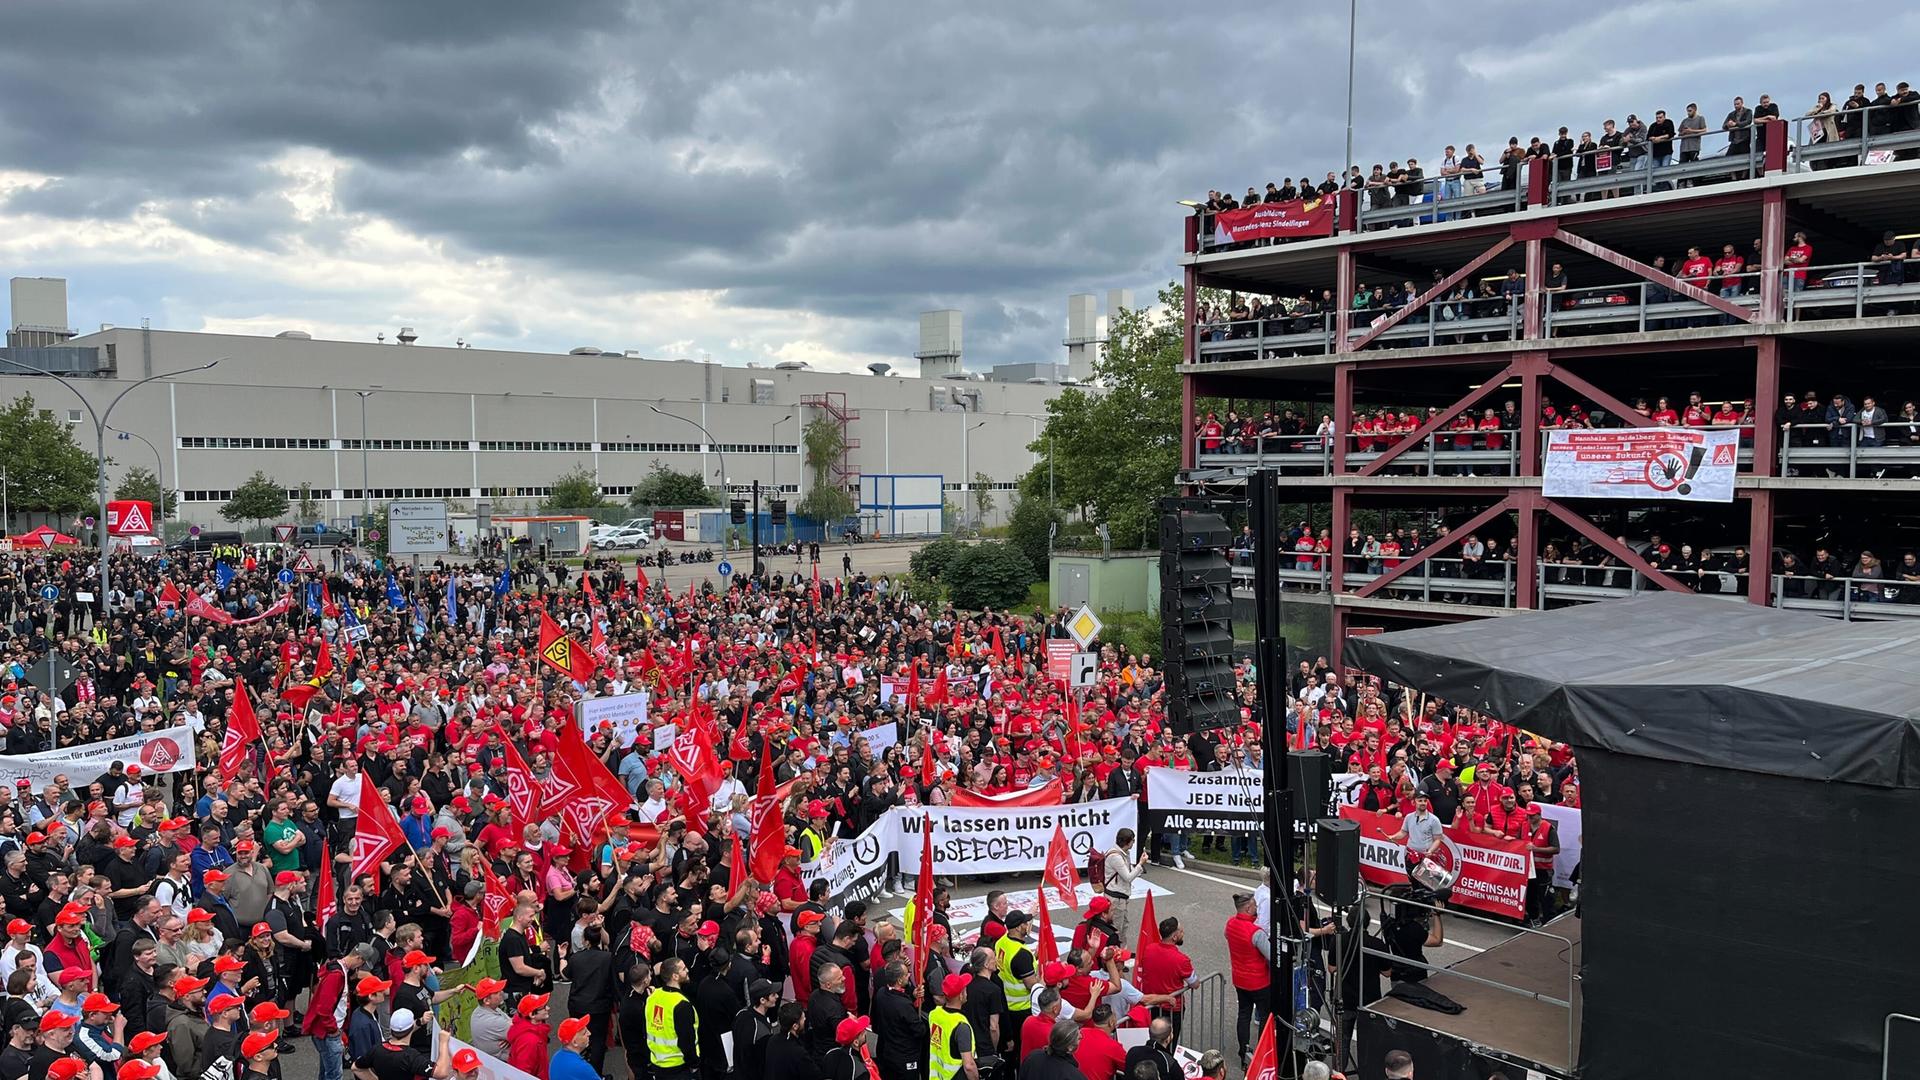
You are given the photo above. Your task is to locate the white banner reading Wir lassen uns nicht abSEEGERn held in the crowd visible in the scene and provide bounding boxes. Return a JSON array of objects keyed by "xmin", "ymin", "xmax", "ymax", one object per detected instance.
[{"xmin": 887, "ymin": 798, "xmax": 1140, "ymax": 878}]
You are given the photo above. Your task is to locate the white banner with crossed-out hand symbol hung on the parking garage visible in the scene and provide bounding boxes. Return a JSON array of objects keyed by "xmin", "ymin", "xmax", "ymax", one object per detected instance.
[{"xmin": 1540, "ymin": 427, "xmax": 1740, "ymax": 502}]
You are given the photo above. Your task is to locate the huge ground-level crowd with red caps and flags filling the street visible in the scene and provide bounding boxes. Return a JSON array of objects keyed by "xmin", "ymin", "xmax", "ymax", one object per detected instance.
[{"xmin": 0, "ymin": 538, "xmax": 1351, "ymax": 1080}]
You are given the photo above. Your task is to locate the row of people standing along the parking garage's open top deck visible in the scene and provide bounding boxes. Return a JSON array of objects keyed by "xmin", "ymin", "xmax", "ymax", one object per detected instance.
[{"xmin": 1198, "ymin": 81, "xmax": 1920, "ymax": 234}]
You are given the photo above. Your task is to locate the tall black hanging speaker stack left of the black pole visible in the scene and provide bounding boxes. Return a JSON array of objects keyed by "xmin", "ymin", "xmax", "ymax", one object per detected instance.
[{"xmin": 1160, "ymin": 500, "xmax": 1240, "ymax": 736}]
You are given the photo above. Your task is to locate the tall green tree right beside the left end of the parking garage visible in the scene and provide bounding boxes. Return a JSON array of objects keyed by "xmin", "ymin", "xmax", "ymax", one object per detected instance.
[{"xmin": 1031, "ymin": 284, "xmax": 1185, "ymax": 546}]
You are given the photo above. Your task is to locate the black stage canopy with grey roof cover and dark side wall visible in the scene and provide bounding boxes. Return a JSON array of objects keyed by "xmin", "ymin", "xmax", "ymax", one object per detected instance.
[{"xmin": 1344, "ymin": 594, "xmax": 1920, "ymax": 1080}]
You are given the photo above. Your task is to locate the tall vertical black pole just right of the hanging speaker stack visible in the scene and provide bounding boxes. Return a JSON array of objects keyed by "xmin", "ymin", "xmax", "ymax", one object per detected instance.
[{"xmin": 1246, "ymin": 469, "xmax": 1298, "ymax": 1036}]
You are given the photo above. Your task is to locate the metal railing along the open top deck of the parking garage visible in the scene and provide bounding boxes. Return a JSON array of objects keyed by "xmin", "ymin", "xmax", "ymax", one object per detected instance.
[{"xmin": 1196, "ymin": 106, "xmax": 1920, "ymax": 252}]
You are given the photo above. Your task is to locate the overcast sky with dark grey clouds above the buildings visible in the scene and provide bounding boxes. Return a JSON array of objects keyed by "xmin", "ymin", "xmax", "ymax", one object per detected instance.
[{"xmin": 0, "ymin": 0, "xmax": 1920, "ymax": 371}]
